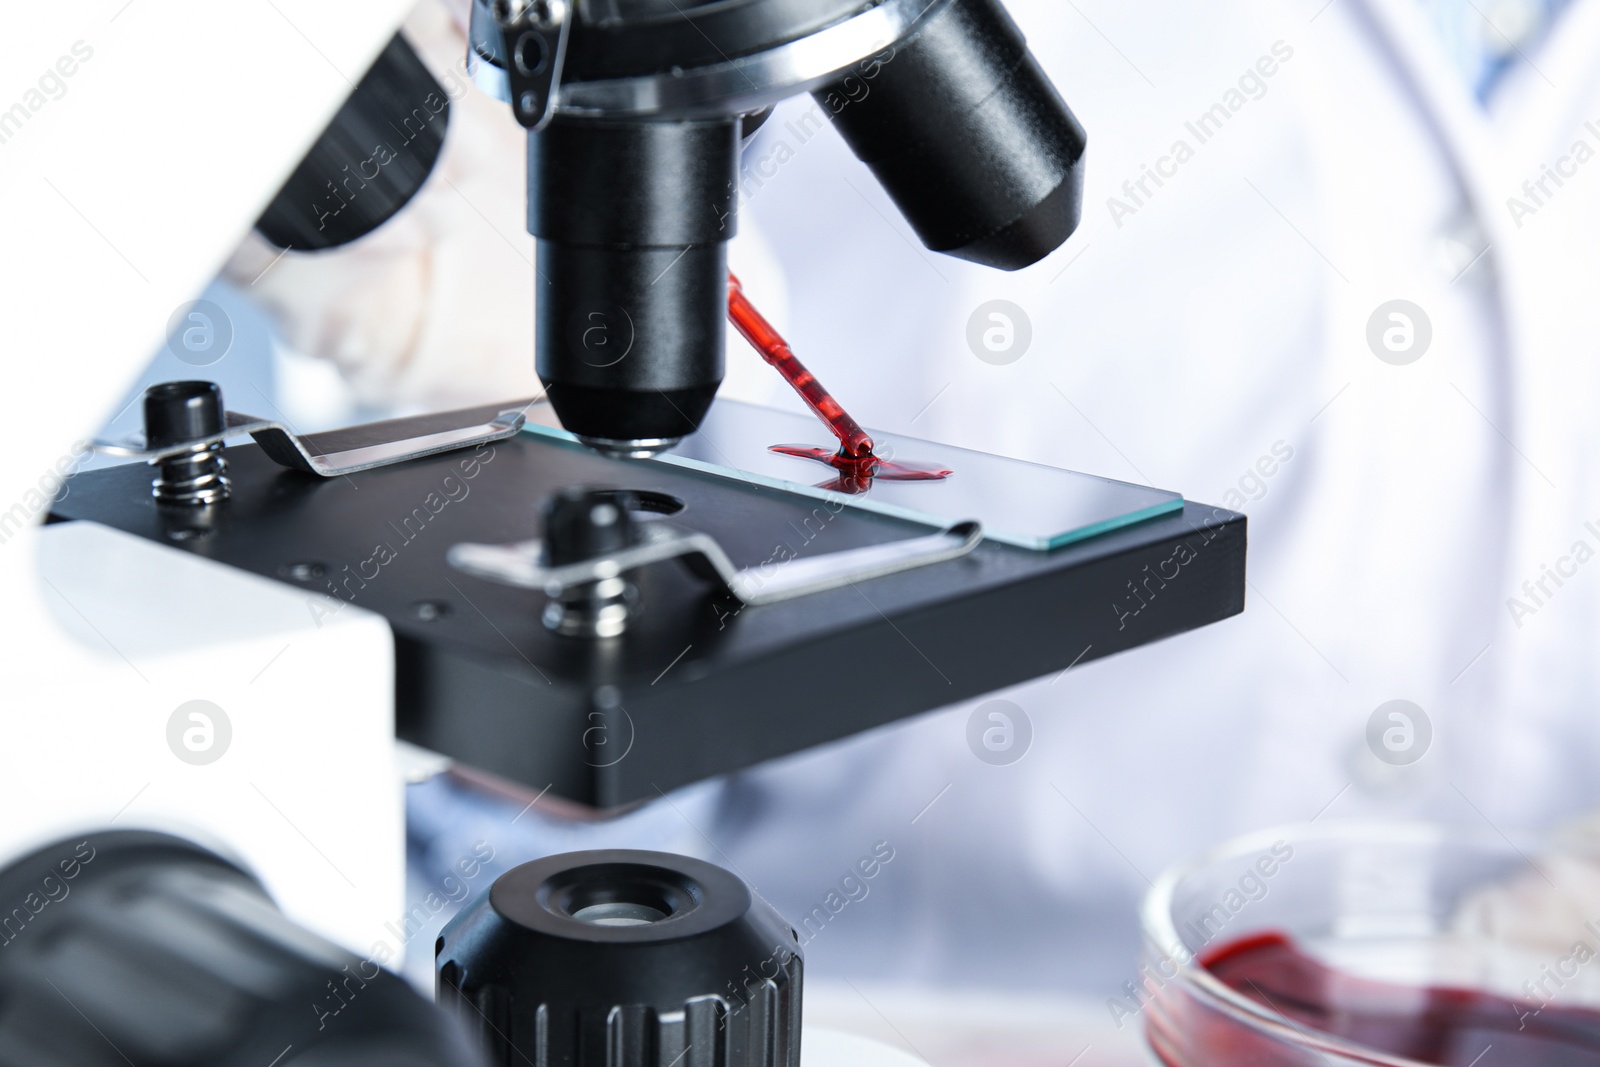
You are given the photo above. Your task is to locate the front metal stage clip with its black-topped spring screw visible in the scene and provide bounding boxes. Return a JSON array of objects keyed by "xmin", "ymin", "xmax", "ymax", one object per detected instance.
[{"xmin": 445, "ymin": 486, "xmax": 984, "ymax": 637}]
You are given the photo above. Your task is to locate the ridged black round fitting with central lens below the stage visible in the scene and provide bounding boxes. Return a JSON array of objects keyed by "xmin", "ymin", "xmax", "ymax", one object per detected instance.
[{"xmin": 435, "ymin": 851, "xmax": 802, "ymax": 1067}]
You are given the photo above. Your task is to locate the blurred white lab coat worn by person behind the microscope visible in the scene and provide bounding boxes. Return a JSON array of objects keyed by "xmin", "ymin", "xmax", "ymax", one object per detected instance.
[{"xmin": 706, "ymin": 0, "xmax": 1600, "ymax": 993}]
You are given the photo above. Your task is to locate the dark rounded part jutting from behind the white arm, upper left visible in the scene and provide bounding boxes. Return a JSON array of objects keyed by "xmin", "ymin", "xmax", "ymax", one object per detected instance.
[{"xmin": 256, "ymin": 34, "xmax": 450, "ymax": 251}]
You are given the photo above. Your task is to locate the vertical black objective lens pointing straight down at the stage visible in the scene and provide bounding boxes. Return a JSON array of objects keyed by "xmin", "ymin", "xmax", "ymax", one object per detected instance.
[{"xmin": 528, "ymin": 117, "xmax": 739, "ymax": 442}]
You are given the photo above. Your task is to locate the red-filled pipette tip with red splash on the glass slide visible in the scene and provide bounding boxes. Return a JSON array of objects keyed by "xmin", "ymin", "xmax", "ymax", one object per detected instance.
[{"xmin": 728, "ymin": 274, "xmax": 954, "ymax": 494}]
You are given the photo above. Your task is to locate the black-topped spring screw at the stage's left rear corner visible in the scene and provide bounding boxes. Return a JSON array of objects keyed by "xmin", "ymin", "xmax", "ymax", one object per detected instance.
[{"xmin": 144, "ymin": 382, "xmax": 232, "ymax": 507}]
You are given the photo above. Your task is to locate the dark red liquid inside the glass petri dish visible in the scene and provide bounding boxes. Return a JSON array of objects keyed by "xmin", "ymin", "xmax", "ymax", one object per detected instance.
[{"xmin": 1150, "ymin": 934, "xmax": 1600, "ymax": 1067}]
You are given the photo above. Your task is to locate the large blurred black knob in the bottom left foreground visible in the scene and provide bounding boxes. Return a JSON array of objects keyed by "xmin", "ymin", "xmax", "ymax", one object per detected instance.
[{"xmin": 0, "ymin": 832, "xmax": 482, "ymax": 1067}]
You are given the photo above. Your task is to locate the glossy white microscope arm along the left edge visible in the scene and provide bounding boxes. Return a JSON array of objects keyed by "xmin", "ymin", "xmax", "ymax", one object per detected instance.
[{"xmin": 0, "ymin": 0, "xmax": 410, "ymax": 952}]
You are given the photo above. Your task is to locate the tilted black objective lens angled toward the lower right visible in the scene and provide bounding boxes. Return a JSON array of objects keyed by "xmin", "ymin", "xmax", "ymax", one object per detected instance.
[{"xmin": 814, "ymin": 0, "xmax": 1086, "ymax": 270}]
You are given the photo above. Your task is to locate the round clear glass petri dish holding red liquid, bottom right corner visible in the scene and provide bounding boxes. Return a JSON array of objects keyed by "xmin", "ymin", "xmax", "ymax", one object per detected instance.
[{"xmin": 1139, "ymin": 822, "xmax": 1600, "ymax": 1067}]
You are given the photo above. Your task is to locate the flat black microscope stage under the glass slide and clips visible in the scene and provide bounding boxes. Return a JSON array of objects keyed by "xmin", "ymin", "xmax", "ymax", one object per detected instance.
[{"xmin": 54, "ymin": 405, "xmax": 1246, "ymax": 808}]
